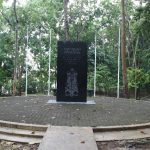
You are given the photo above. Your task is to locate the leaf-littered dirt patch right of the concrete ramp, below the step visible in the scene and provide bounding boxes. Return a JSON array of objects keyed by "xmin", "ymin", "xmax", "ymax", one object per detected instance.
[{"xmin": 97, "ymin": 138, "xmax": 150, "ymax": 150}]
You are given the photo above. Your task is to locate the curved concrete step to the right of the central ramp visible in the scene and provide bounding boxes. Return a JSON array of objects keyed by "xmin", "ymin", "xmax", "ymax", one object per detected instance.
[{"xmin": 93, "ymin": 123, "xmax": 150, "ymax": 141}]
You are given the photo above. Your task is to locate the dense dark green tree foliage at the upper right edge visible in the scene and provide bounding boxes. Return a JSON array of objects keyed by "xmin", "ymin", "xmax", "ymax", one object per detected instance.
[{"xmin": 131, "ymin": 3, "xmax": 150, "ymax": 57}]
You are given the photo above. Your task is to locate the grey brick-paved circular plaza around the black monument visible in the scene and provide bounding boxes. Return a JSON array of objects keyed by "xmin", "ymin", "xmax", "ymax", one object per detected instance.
[{"xmin": 0, "ymin": 96, "xmax": 150, "ymax": 127}]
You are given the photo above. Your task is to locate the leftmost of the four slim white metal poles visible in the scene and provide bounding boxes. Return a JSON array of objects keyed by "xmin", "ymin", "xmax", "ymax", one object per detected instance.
[{"xmin": 25, "ymin": 27, "xmax": 29, "ymax": 96}]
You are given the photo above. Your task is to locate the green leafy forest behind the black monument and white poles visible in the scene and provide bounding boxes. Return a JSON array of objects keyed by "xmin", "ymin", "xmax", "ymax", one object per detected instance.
[{"xmin": 0, "ymin": 0, "xmax": 150, "ymax": 97}]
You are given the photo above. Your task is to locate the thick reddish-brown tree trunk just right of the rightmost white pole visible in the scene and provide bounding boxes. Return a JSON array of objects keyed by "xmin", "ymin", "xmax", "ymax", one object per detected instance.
[{"xmin": 121, "ymin": 0, "xmax": 129, "ymax": 98}]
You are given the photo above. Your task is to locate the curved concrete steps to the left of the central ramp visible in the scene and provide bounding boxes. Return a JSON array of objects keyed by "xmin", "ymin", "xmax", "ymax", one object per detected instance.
[{"xmin": 0, "ymin": 121, "xmax": 47, "ymax": 144}]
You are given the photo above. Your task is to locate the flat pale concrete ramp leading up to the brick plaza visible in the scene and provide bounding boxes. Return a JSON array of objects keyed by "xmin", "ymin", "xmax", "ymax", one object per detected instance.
[{"xmin": 38, "ymin": 126, "xmax": 98, "ymax": 150}]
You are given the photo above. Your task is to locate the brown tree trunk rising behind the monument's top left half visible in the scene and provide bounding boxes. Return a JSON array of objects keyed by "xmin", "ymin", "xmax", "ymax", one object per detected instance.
[{"xmin": 64, "ymin": 0, "xmax": 69, "ymax": 41}]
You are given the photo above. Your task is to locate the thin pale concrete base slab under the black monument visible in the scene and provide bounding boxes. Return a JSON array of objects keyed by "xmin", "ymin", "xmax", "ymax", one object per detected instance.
[{"xmin": 47, "ymin": 100, "xmax": 96, "ymax": 105}]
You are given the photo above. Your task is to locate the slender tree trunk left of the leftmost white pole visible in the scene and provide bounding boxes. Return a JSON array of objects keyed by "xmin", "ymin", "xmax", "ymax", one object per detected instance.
[{"xmin": 13, "ymin": 0, "xmax": 18, "ymax": 95}]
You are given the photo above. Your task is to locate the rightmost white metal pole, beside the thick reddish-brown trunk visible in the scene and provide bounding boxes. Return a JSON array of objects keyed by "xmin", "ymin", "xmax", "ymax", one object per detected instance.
[{"xmin": 117, "ymin": 24, "xmax": 120, "ymax": 98}]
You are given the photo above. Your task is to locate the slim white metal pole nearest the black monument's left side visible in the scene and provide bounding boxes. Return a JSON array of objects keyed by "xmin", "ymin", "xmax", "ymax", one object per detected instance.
[{"xmin": 48, "ymin": 29, "xmax": 52, "ymax": 96}]
